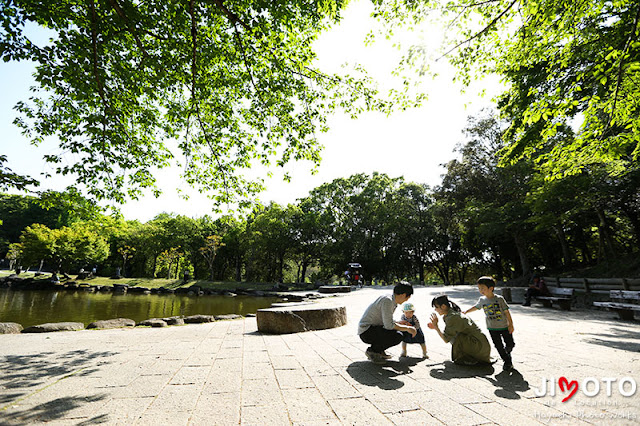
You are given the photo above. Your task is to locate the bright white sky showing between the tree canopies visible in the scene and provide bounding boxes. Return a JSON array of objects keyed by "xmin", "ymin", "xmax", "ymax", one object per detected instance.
[{"xmin": 0, "ymin": 0, "xmax": 501, "ymax": 222}]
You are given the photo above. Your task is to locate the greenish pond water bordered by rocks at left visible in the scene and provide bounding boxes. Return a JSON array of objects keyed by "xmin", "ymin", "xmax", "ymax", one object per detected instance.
[{"xmin": 0, "ymin": 289, "xmax": 280, "ymax": 328}]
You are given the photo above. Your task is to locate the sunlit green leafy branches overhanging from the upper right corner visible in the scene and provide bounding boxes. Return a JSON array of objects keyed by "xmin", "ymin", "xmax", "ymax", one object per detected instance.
[{"xmin": 374, "ymin": 0, "xmax": 640, "ymax": 177}]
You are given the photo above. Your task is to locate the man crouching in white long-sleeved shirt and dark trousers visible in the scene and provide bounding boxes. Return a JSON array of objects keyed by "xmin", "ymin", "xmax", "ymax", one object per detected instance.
[{"xmin": 358, "ymin": 281, "xmax": 416, "ymax": 364}]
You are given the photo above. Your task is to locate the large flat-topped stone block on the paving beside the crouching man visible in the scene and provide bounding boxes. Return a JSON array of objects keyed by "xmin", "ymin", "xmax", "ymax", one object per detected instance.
[{"xmin": 256, "ymin": 305, "xmax": 347, "ymax": 334}]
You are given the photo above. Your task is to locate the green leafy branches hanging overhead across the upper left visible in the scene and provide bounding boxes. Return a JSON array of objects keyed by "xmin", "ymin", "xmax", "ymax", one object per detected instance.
[{"xmin": 0, "ymin": 0, "xmax": 418, "ymax": 203}]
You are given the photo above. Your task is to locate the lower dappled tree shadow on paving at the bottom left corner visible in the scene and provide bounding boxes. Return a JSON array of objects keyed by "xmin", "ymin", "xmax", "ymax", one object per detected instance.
[{"xmin": 0, "ymin": 394, "xmax": 108, "ymax": 425}]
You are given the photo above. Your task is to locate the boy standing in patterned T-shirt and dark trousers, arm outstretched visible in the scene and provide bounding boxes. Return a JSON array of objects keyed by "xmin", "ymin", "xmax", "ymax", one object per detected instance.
[{"xmin": 463, "ymin": 277, "xmax": 515, "ymax": 371}]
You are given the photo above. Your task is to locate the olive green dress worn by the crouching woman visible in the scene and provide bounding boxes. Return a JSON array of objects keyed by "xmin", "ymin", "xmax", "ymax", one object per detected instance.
[{"xmin": 443, "ymin": 310, "xmax": 491, "ymax": 365}]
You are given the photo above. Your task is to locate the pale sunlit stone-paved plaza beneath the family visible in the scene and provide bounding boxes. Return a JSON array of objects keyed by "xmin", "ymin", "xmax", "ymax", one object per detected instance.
[{"xmin": 0, "ymin": 286, "xmax": 640, "ymax": 425}]
